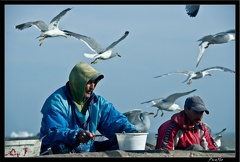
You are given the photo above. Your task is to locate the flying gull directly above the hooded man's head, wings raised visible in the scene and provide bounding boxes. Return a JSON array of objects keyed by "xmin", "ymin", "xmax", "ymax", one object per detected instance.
[{"xmin": 62, "ymin": 30, "xmax": 129, "ymax": 64}]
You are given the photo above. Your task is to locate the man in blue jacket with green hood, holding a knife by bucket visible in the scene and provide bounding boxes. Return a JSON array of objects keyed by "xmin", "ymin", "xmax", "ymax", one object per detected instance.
[{"xmin": 40, "ymin": 62, "xmax": 137, "ymax": 155}]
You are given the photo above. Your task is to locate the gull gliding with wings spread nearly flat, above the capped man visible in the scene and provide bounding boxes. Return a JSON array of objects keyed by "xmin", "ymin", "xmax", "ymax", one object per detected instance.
[{"xmin": 154, "ymin": 66, "xmax": 235, "ymax": 85}]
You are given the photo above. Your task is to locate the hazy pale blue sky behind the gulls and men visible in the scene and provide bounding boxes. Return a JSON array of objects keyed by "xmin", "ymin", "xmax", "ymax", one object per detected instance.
[{"xmin": 5, "ymin": 4, "xmax": 236, "ymax": 137}]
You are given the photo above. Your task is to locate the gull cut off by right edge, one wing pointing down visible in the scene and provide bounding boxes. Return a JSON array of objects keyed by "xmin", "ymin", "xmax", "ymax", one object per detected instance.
[{"xmin": 196, "ymin": 29, "xmax": 235, "ymax": 68}]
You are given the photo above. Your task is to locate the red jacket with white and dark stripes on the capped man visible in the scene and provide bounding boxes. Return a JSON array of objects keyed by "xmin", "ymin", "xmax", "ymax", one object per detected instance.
[{"xmin": 156, "ymin": 111, "xmax": 217, "ymax": 150}]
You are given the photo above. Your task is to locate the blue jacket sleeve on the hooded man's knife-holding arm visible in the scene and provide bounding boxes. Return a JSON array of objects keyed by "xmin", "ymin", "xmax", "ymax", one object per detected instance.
[{"xmin": 40, "ymin": 90, "xmax": 82, "ymax": 147}]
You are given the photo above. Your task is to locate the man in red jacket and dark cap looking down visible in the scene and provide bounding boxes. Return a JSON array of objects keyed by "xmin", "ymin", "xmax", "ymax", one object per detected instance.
[{"xmin": 155, "ymin": 96, "xmax": 217, "ymax": 150}]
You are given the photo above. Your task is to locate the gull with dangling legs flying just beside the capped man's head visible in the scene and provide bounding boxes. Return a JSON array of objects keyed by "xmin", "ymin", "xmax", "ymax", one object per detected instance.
[{"xmin": 141, "ymin": 89, "xmax": 197, "ymax": 118}]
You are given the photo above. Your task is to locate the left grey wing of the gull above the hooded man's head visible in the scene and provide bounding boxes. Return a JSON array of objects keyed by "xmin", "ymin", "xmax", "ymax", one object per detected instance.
[{"xmin": 63, "ymin": 30, "xmax": 104, "ymax": 53}]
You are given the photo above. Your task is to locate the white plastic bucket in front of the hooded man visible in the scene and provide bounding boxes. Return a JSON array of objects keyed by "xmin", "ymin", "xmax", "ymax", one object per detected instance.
[{"xmin": 116, "ymin": 133, "xmax": 148, "ymax": 150}]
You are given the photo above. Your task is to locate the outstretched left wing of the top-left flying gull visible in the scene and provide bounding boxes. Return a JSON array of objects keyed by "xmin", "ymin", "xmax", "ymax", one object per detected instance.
[{"xmin": 15, "ymin": 21, "xmax": 48, "ymax": 32}]
